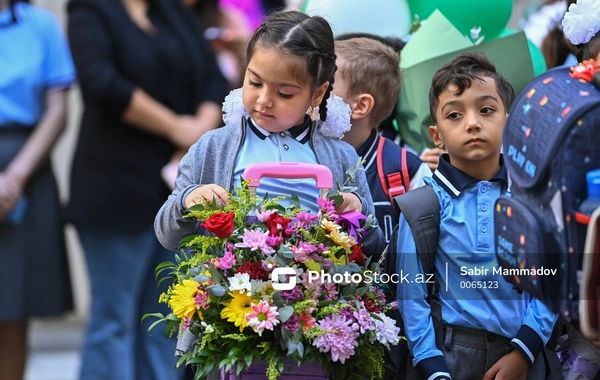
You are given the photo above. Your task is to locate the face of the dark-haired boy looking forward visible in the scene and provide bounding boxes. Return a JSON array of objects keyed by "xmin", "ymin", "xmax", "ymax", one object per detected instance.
[{"xmin": 429, "ymin": 77, "xmax": 507, "ymax": 178}]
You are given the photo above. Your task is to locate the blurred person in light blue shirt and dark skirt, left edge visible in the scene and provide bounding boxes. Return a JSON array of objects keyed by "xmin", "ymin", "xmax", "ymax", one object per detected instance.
[{"xmin": 0, "ymin": 0, "xmax": 75, "ymax": 380}]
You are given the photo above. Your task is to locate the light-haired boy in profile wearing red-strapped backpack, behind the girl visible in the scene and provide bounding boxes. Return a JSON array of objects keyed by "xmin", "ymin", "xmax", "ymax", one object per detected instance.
[{"xmin": 331, "ymin": 37, "xmax": 431, "ymax": 244}]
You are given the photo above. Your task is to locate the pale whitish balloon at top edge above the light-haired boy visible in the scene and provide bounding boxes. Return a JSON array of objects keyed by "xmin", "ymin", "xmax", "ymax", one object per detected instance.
[{"xmin": 301, "ymin": 0, "xmax": 411, "ymax": 38}]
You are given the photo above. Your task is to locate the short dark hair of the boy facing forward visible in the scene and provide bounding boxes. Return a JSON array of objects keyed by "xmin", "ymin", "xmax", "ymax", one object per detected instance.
[{"xmin": 429, "ymin": 52, "xmax": 515, "ymax": 124}]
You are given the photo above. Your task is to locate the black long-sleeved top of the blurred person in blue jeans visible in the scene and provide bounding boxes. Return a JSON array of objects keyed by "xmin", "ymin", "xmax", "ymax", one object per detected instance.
[{"xmin": 66, "ymin": 0, "xmax": 227, "ymax": 231}]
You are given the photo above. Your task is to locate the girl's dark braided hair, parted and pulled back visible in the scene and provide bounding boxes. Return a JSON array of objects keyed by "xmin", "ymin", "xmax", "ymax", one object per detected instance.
[{"xmin": 246, "ymin": 11, "xmax": 337, "ymax": 121}]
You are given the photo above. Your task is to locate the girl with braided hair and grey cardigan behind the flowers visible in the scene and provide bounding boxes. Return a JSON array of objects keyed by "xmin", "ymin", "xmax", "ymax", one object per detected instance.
[{"xmin": 154, "ymin": 11, "xmax": 384, "ymax": 254}]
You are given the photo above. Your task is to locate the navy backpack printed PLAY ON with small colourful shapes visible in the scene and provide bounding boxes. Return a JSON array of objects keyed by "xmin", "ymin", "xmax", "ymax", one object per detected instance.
[{"xmin": 494, "ymin": 62, "xmax": 600, "ymax": 319}]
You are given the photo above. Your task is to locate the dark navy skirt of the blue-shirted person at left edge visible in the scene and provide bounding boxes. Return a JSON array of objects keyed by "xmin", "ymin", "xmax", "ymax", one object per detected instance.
[{"xmin": 0, "ymin": 128, "xmax": 73, "ymax": 321}]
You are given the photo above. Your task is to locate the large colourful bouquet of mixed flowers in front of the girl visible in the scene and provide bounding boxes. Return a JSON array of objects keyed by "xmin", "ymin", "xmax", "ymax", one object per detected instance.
[{"xmin": 144, "ymin": 165, "xmax": 399, "ymax": 380}]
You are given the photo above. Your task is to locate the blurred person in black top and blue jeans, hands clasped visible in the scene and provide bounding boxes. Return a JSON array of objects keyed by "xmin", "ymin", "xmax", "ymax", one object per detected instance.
[{"xmin": 67, "ymin": 0, "xmax": 227, "ymax": 380}]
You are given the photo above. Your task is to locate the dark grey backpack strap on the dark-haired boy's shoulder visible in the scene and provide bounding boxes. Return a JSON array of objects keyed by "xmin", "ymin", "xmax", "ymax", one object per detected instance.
[{"xmin": 394, "ymin": 186, "xmax": 444, "ymax": 350}]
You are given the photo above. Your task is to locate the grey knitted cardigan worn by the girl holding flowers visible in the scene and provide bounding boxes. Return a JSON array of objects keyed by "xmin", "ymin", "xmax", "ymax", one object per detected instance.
[{"xmin": 154, "ymin": 119, "xmax": 385, "ymax": 257}]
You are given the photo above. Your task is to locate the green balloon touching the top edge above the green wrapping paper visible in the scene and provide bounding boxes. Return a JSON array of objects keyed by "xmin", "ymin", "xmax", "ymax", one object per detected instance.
[{"xmin": 408, "ymin": 0, "xmax": 513, "ymax": 40}]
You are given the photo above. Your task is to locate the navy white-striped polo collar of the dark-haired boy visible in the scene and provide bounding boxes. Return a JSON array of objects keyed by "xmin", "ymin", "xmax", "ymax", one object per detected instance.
[{"xmin": 433, "ymin": 153, "xmax": 508, "ymax": 198}]
